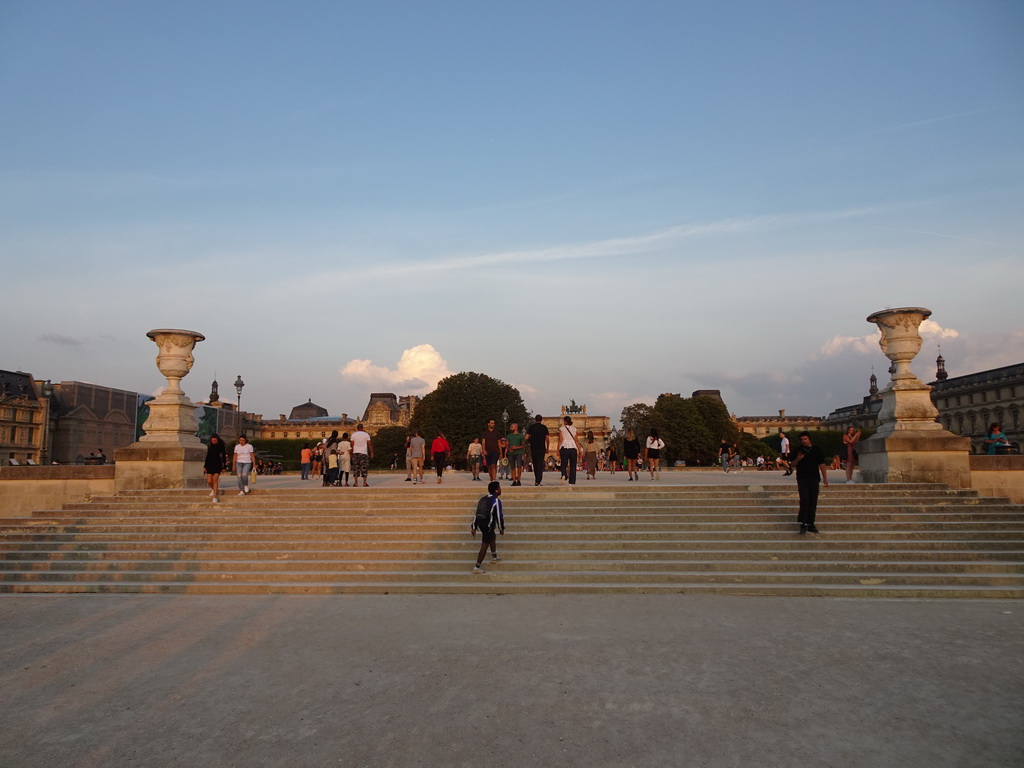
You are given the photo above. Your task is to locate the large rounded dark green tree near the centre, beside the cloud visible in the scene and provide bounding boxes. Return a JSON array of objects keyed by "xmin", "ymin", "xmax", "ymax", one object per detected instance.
[{"xmin": 410, "ymin": 373, "xmax": 529, "ymax": 460}]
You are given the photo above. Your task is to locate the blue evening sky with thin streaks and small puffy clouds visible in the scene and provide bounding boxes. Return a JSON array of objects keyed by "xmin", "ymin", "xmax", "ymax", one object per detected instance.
[{"xmin": 0, "ymin": 0, "xmax": 1024, "ymax": 421}]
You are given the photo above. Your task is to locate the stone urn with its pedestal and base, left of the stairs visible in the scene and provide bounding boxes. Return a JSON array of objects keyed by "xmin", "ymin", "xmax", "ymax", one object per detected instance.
[{"xmin": 114, "ymin": 328, "xmax": 206, "ymax": 492}]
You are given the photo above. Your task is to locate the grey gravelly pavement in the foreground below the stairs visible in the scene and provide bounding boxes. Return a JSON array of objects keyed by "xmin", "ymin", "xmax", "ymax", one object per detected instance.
[{"xmin": 0, "ymin": 593, "xmax": 1024, "ymax": 768}]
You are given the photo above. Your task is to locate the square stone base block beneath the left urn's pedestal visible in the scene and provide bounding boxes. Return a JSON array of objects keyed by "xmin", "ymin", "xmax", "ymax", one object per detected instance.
[{"xmin": 114, "ymin": 440, "xmax": 206, "ymax": 493}]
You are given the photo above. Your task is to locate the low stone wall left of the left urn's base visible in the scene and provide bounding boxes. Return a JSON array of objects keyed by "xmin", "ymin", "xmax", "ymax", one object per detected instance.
[{"xmin": 0, "ymin": 465, "xmax": 115, "ymax": 518}]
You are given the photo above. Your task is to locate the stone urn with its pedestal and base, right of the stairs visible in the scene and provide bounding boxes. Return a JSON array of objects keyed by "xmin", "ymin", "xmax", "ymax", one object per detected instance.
[{"xmin": 858, "ymin": 307, "xmax": 971, "ymax": 488}]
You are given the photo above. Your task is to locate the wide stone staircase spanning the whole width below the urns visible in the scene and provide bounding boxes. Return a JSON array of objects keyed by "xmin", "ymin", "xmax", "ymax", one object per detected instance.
[{"xmin": 0, "ymin": 484, "xmax": 1024, "ymax": 598}]
